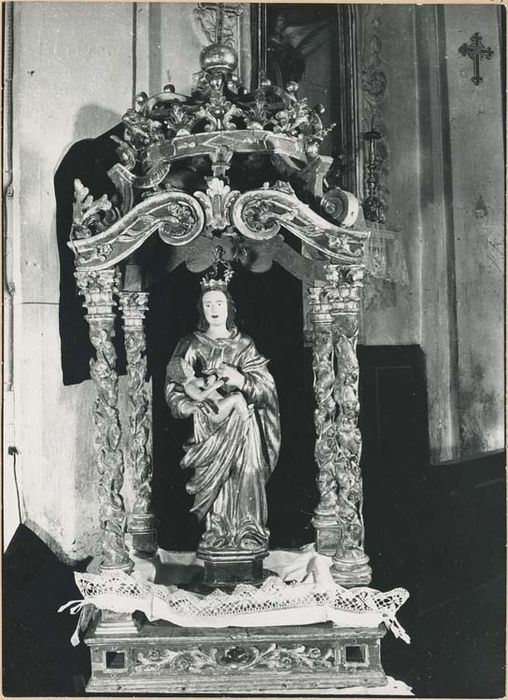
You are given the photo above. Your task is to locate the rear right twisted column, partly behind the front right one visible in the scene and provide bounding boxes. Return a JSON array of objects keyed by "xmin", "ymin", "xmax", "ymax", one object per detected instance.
[{"xmin": 309, "ymin": 286, "xmax": 339, "ymax": 555}]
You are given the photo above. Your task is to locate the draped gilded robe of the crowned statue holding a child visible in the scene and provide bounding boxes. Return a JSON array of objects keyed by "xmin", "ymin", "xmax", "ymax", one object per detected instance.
[{"xmin": 165, "ymin": 328, "xmax": 280, "ymax": 550}]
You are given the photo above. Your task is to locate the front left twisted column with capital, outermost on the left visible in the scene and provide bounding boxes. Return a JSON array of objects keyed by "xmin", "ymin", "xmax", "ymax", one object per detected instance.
[{"xmin": 75, "ymin": 270, "xmax": 132, "ymax": 571}]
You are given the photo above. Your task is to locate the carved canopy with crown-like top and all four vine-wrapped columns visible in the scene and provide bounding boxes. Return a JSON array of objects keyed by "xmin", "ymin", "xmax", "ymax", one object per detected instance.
[{"xmin": 69, "ymin": 24, "xmax": 371, "ymax": 585}]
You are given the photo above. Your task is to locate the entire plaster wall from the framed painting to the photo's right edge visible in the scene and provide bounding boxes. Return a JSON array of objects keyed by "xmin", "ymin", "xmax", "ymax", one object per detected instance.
[{"xmin": 358, "ymin": 5, "xmax": 504, "ymax": 462}]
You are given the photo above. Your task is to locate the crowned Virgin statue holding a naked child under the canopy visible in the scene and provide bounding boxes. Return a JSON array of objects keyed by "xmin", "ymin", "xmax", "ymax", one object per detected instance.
[{"xmin": 165, "ymin": 268, "xmax": 280, "ymax": 581}]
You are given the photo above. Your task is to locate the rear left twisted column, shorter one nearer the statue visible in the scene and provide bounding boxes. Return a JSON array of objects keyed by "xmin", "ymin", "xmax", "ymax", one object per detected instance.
[{"xmin": 118, "ymin": 292, "xmax": 157, "ymax": 554}]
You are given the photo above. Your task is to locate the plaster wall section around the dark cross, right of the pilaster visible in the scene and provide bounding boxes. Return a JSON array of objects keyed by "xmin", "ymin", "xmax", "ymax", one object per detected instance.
[{"xmin": 443, "ymin": 5, "xmax": 505, "ymax": 456}]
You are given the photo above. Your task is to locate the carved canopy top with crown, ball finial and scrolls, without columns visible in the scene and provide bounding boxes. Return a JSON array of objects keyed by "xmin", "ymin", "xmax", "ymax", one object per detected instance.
[{"xmin": 69, "ymin": 34, "xmax": 369, "ymax": 282}]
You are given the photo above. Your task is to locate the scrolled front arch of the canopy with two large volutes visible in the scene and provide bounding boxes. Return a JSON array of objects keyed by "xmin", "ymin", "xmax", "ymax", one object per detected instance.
[{"xmin": 69, "ymin": 178, "xmax": 369, "ymax": 271}]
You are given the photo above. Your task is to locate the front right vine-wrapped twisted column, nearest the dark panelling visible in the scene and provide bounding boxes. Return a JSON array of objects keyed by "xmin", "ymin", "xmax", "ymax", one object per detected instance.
[{"xmin": 330, "ymin": 266, "xmax": 372, "ymax": 587}]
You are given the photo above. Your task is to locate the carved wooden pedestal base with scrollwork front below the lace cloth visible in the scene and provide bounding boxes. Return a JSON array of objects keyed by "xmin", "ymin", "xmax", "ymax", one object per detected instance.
[{"xmin": 85, "ymin": 622, "xmax": 387, "ymax": 694}]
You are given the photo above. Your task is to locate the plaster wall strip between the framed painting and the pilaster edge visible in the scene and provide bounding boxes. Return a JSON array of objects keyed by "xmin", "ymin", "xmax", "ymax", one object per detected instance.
[{"xmin": 358, "ymin": 5, "xmax": 421, "ymax": 345}]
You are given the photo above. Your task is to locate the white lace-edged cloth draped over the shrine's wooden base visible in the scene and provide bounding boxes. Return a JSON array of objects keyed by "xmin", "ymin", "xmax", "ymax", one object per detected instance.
[{"xmin": 59, "ymin": 550, "xmax": 409, "ymax": 644}]
